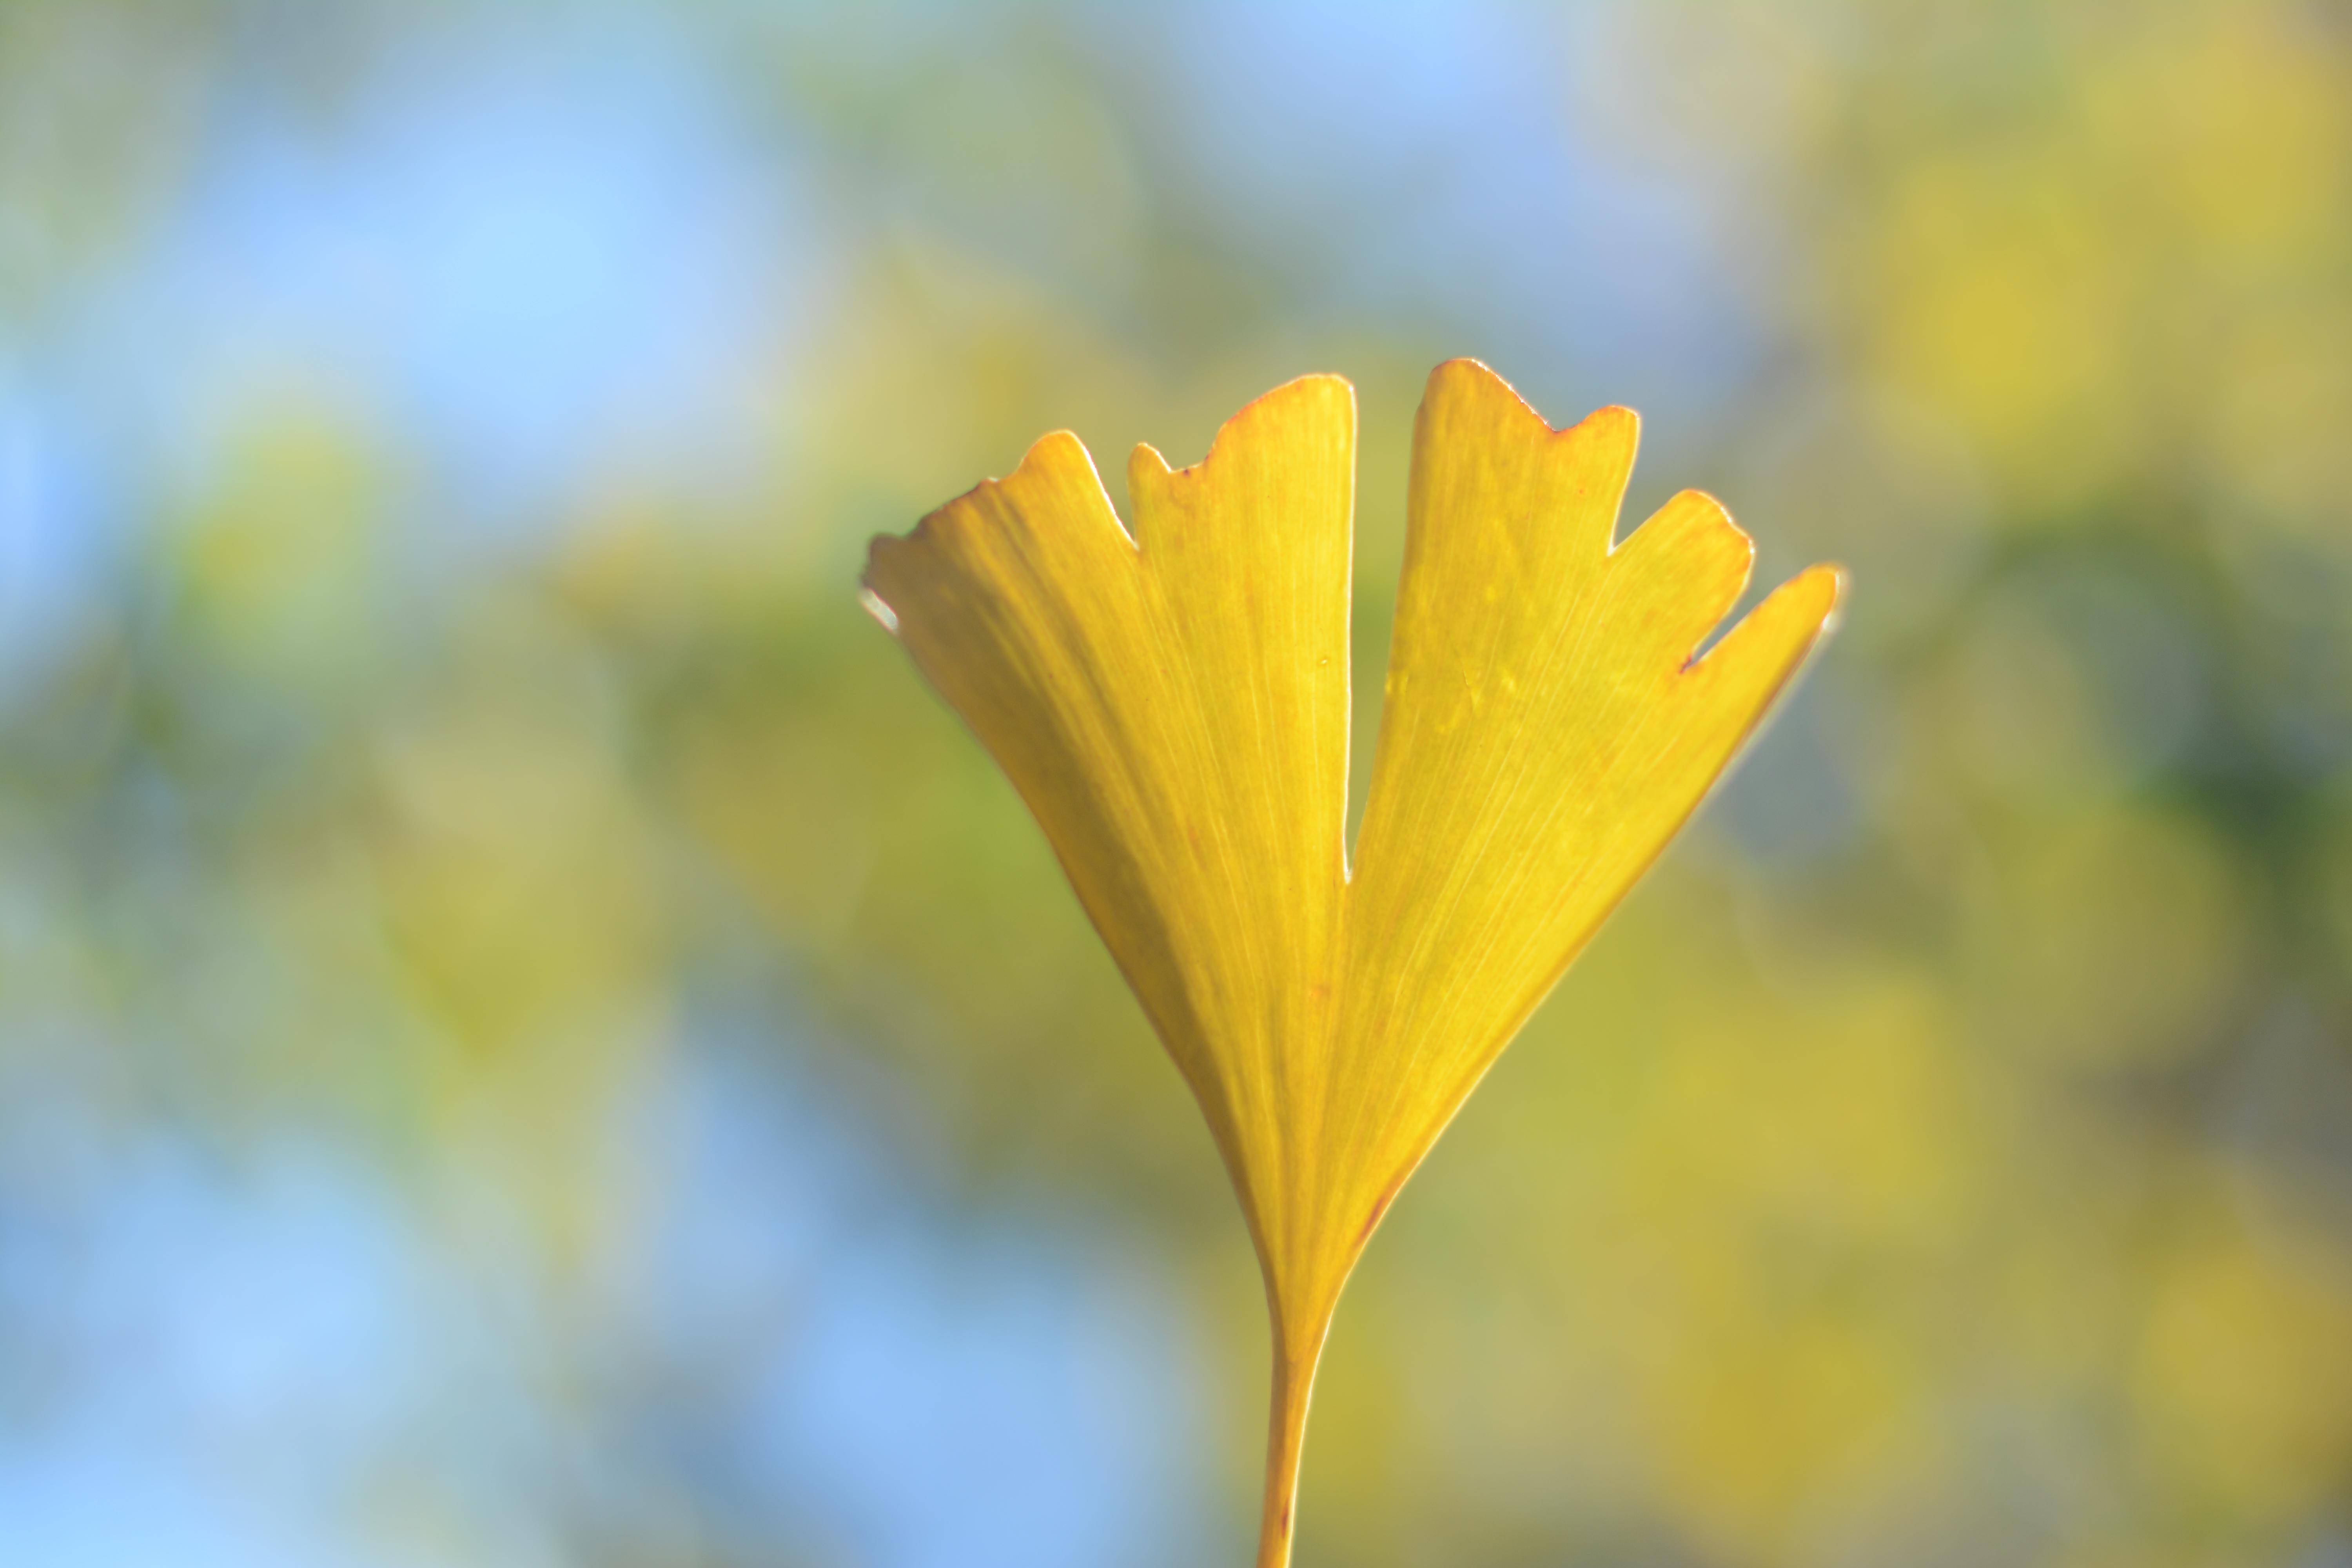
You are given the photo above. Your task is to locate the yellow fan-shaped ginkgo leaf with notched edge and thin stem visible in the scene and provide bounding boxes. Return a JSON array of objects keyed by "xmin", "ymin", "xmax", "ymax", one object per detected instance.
[{"xmin": 866, "ymin": 360, "xmax": 1839, "ymax": 1568}]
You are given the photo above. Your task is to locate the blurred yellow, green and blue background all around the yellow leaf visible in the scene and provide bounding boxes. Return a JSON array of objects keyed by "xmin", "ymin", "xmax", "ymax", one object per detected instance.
[{"xmin": 0, "ymin": 0, "xmax": 2352, "ymax": 1568}]
